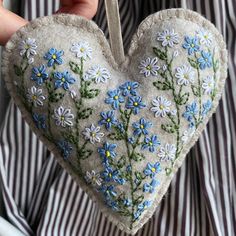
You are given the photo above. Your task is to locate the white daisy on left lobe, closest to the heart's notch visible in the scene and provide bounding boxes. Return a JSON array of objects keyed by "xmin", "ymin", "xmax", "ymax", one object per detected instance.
[{"xmin": 84, "ymin": 65, "xmax": 110, "ymax": 83}]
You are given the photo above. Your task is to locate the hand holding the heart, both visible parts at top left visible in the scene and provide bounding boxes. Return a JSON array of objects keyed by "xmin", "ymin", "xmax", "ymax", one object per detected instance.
[{"xmin": 0, "ymin": 0, "xmax": 98, "ymax": 45}]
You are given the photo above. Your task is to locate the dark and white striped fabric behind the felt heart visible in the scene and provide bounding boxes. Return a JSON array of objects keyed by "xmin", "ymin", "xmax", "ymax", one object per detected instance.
[{"xmin": 0, "ymin": 0, "xmax": 236, "ymax": 236}]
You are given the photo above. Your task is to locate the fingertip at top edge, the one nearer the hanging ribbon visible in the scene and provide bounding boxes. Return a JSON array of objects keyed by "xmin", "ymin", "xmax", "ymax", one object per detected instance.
[{"xmin": 57, "ymin": 0, "xmax": 98, "ymax": 19}]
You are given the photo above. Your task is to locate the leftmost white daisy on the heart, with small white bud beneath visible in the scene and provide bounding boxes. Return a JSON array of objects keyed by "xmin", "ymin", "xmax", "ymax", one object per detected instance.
[{"xmin": 19, "ymin": 38, "xmax": 37, "ymax": 64}]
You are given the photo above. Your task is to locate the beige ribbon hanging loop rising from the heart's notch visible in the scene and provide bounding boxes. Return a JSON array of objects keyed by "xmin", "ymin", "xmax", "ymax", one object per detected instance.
[{"xmin": 105, "ymin": 0, "xmax": 125, "ymax": 65}]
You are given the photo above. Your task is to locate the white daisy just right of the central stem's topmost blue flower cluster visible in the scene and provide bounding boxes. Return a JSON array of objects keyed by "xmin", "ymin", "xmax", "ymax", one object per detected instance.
[{"xmin": 151, "ymin": 96, "xmax": 171, "ymax": 117}]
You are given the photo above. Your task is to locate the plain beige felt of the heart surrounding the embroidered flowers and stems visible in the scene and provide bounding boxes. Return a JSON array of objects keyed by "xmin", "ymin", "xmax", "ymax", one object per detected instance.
[{"xmin": 3, "ymin": 9, "xmax": 227, "ymax": 234}]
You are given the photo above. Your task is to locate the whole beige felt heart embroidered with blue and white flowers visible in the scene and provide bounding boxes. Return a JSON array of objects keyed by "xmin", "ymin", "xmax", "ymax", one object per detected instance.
[{"xmin": 3, "ymin": 9, "xmax": 227, "ymax": 234}]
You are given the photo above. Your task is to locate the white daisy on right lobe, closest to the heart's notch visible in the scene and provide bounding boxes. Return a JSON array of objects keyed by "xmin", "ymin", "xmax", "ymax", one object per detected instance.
[{"xmin": 138, "ymin": 57, "xmax": 160, "ymax": 77}]
